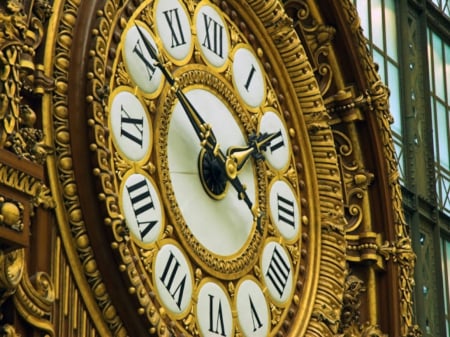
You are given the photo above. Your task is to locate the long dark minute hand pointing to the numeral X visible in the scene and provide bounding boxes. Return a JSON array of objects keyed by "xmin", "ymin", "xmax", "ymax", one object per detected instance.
[{"xmin": 135, "ymin": 24, "xmax": 217, "ymax": 151}]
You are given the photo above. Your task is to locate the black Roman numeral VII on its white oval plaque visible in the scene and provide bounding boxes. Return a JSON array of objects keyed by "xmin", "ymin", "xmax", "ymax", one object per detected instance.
[{"xmin": 159, "ymin": 251, "xmax": 187, "ymax": 310}]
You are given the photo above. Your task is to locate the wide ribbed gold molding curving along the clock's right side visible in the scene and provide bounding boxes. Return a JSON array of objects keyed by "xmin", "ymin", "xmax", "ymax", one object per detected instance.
[{"xmin": 241, "ymin": 0, "xmax": 346, "ymax": 336}]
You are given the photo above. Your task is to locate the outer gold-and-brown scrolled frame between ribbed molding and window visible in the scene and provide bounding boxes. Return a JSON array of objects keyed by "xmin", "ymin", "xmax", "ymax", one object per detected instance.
[{"xmin": 286, "ymin": 0, "xmax": 417, "ymax": 336}]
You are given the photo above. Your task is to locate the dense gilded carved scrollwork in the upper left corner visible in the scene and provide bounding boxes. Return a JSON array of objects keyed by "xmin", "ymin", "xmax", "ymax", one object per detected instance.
[{"xmin": 0, "ymin": 0, "xmax": 54, "ymax": 164}]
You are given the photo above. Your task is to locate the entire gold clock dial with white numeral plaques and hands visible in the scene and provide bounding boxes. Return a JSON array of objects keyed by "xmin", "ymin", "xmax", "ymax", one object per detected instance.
[{"xmin": 89, "ymin": 0, "xmax": 319, "ymax": 336}]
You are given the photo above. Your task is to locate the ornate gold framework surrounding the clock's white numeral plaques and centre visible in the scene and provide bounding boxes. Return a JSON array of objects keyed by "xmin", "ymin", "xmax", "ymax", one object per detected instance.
[{"xmin": 88, "ymin": 1, "xmax": 319, "ymax": 335}]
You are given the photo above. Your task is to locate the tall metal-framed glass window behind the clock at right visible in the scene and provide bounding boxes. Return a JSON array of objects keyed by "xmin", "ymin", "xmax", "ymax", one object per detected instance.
[{"xmin": 353, "ymin": 0, "xmax": 450, "ymax": 337}]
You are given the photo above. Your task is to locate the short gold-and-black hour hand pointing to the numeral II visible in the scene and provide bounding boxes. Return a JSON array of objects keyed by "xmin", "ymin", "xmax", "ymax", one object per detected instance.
[{"xmin": 226, "ymin": 132, "xmax": 278, "ymax": 177}]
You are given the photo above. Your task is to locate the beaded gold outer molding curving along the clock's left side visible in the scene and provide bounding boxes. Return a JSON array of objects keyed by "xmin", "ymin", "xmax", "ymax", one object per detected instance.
[{"xmin": 42, "ymin": 0, "xmax": 126, "ymax": 336}]
